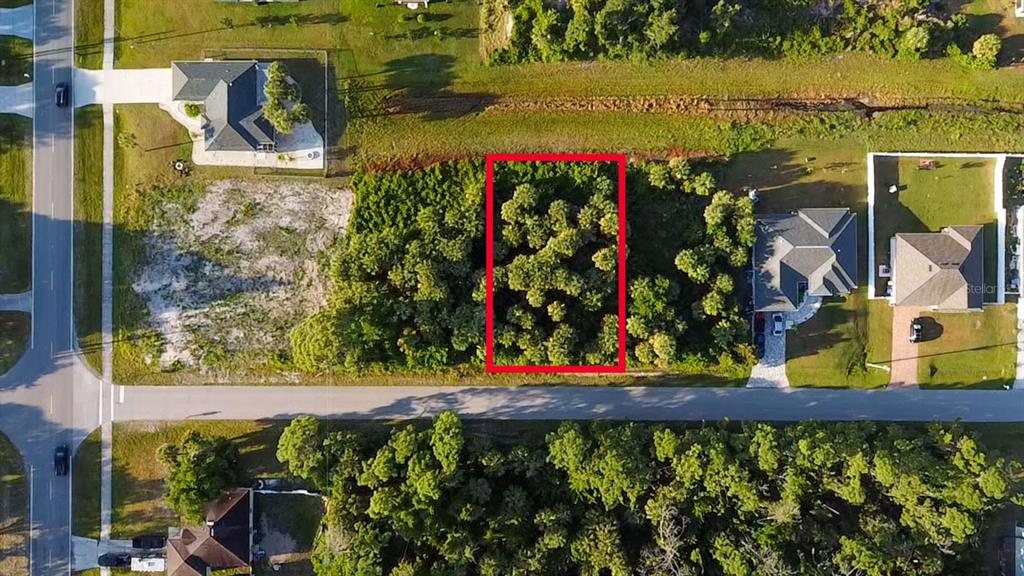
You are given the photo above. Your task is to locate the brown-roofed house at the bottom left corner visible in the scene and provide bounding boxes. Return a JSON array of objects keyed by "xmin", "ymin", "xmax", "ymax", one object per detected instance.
[{"xmin": 166, "ymin": 488, "xmax": 253, "ymax": 576}]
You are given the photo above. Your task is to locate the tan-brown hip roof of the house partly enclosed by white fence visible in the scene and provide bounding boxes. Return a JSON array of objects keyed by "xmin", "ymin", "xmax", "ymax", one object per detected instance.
[{"xmin": 891, "ymin": 225, "xmax": 985, "ymax": 311}]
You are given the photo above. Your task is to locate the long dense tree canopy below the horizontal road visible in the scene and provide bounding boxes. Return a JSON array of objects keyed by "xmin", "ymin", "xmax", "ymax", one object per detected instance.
[{"xmin": 285, "ymin": 413, "xmax": 1020, "ymax": 576}]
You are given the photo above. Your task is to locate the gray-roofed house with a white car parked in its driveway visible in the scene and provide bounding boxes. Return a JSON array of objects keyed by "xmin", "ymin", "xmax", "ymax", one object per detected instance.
[{"xmin": 753, "ymin": 208, "xmax": 857, "ymax": 312}]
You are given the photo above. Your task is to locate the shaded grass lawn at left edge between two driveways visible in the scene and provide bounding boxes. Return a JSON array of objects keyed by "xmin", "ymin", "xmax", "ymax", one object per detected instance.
[{"xmin": 0, "ymin": 114, "xmax": 32, "ymax": 293}]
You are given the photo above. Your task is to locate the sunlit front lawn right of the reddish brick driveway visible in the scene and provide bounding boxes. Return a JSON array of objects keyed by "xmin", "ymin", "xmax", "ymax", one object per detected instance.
[{"xmin": 918, "ymin": 304, "xmax": 1017, "ymax": 388}]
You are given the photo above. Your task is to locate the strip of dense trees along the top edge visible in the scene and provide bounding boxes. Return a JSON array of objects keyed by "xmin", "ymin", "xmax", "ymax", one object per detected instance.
[{"xmin": 483, "ymin": 0, "xmax": 973, "ymax": 64}]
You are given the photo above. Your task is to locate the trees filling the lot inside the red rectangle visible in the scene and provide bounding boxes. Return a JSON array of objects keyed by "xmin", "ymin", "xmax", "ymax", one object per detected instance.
[{"xmin": 494, "ymin": 158, "xmax": 618, "ymax": 365}]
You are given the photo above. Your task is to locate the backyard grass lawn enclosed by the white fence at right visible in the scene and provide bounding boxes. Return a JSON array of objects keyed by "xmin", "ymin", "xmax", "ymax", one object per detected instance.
[{"xmin": 874, "ymin": 157, "xmax": 997, "ymax": 295}]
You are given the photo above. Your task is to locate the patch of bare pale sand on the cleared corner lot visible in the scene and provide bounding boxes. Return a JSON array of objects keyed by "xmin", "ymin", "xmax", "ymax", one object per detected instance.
[{"xmin": 132, "ymin": 180, "xmax": 352, "ymax": 369}]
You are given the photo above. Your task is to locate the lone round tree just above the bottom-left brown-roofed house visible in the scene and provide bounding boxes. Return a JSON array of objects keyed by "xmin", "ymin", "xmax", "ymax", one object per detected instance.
[{"xmin": 157, "ymin": 430, "xmax": 239, "ymax": 523}]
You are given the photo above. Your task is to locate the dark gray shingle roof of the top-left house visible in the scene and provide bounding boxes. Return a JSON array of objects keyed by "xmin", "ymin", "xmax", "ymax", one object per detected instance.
[{"xmin": 171, "ymin": 60, "xmax": 276, "ymax": 153}]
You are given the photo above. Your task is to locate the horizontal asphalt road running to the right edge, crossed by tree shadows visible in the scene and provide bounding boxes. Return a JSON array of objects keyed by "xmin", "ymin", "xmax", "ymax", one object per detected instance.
[{"xmin": 114, "ymin": 386, "xmax": 1024, "ymax": 422}]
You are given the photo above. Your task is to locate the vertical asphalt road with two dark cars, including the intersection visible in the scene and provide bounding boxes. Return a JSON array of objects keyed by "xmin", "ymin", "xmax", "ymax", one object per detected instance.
[{"xmin": 0, "ymin": 0, "xmax": 99, "ymax": 576}]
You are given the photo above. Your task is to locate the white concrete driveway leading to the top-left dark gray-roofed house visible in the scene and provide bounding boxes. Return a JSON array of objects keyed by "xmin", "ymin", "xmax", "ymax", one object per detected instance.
[{"xmin": 75, "ymin": 68, "xmax": 171, "ymax": 107}]
